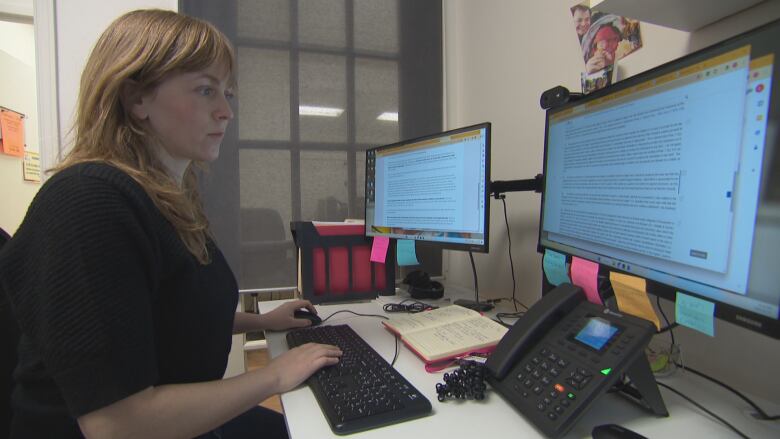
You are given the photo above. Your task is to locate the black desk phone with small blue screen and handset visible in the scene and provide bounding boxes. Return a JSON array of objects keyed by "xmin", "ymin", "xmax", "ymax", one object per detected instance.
[{"xmin": 486, "ymin": 284, "xmax": 668, "ymax": 437}]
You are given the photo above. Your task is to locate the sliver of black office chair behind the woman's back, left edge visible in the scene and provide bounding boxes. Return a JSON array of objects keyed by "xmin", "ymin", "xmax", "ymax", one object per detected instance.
[{"xmin": 0, "ymin": 229, "xmax": 19, "ymax": 437}]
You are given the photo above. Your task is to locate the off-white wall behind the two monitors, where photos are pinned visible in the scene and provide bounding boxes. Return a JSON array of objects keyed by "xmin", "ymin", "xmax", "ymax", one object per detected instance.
[{"xmin": 444, "ymin": 0, "xmax": 780, "ymax": 403}]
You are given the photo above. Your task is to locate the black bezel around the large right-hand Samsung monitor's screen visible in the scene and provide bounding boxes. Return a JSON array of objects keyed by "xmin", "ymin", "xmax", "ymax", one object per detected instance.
[{"xmin": 537, "ymin": 20, "xmax": 780, "ymax": 339}]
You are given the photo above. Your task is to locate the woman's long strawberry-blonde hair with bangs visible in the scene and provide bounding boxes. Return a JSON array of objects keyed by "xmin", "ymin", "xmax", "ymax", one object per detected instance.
[{"xmin": 55, "ymin": 9, "xmax": 235, "ymax": 265}]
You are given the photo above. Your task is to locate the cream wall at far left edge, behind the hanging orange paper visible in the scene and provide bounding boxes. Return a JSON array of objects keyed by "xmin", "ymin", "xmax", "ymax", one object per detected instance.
[{"xmin": 0, "ymin": 20, "xmax": 40, "ymax": 235}]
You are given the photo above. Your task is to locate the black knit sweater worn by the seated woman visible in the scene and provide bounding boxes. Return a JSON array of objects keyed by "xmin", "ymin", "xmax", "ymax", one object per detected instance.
[{"xmin": 0, "ymin": 164, "xmax": 238, "ymax": 438}]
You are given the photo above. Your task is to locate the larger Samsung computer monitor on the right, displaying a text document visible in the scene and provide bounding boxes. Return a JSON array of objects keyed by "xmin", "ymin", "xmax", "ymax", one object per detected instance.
[{"xmin": 539, "ymin": 21, "xmax": 780, "ymax": 338}]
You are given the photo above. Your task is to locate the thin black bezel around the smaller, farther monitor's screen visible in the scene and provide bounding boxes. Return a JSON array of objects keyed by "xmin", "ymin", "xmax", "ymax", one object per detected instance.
[{"xmin": 363, "ymin": 122, "xmax": 492, "ymax": 253}]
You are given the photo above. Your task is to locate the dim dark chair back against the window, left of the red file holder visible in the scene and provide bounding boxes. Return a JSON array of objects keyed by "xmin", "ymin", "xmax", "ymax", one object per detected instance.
[{"xmin": 239, "ymin": 208, "xmax": 295, "ymax": 289}]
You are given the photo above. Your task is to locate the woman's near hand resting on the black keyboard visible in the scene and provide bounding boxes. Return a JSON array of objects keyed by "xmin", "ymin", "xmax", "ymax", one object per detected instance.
[{"xmin": 266, "ymin": 343, "xmax": 342, "ymax": 393}]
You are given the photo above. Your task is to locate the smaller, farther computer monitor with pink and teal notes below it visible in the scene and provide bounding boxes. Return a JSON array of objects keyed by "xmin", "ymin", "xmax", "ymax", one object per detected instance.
[{"xmin": 366, "ymin": 123, "xmax": 490, "ymax": 253}]
